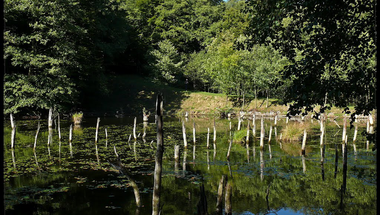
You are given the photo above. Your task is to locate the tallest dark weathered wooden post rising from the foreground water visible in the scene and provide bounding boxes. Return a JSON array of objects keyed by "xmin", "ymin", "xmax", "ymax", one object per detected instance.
[{"xmin": 152, "ymin": 94, "xmax": 164, "ymax": 215}]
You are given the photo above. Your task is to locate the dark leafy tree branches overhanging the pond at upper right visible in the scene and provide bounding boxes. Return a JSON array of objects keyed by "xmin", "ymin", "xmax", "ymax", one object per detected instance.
[{"xmin": 248, "ymin": 0, "xmax": 377, "ymax": 114}]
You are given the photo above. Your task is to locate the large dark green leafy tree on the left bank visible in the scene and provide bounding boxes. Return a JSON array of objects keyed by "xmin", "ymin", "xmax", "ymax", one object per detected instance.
[{"xmin": 4, "ymin": 0, "xmax": 132, "ymax": 113}]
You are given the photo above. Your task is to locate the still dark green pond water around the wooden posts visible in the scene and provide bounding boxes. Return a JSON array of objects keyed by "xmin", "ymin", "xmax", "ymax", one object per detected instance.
[{"xmin": 3, "ymin": 117, "xmax": 377, "ymax": 215}]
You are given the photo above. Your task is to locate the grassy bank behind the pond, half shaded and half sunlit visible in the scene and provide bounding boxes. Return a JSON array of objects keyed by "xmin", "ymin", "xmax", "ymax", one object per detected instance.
[{"xmin": 83, "ymin": 75, "xmax": 374, "ymax": 116}]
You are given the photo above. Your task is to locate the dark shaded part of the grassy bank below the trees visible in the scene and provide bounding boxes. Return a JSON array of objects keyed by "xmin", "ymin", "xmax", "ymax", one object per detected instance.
[{"xmin": 83, "ymin": 75, "xmax": 186, "ymax": 117}]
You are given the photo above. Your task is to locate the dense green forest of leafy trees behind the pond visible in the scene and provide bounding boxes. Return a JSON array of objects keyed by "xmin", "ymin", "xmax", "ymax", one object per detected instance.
[{"xmin": 3, "ymin": 0, "xmax": 377, "ymax": 115}]
